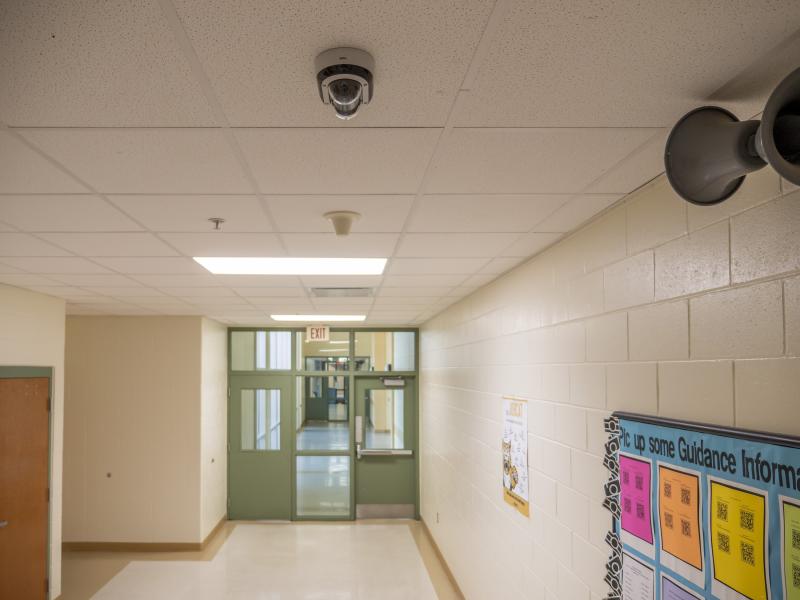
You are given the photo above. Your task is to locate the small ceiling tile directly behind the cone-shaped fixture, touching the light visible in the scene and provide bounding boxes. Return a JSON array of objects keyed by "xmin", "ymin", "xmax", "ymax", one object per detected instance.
[{"xmin": 282, "ymin": 233, "xmax": 400, "ymax": 258}]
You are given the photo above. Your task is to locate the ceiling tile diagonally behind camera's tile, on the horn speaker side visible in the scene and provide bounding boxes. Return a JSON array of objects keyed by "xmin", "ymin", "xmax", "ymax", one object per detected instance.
[{"xmin": 427, "ymin": 128, "xmax": 654, "ymax": 194}]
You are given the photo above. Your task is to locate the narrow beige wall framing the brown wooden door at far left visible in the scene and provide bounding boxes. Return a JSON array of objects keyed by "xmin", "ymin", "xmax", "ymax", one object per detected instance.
[{"xmin": 0, "ymin": 285, "xmax": 64, "ymax": 598}]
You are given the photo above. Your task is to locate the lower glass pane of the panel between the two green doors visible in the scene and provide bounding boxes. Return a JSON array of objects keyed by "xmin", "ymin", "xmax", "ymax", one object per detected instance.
[{"xmin": 296, "ymin": 456, "xmax": 350, "ymax": 517}]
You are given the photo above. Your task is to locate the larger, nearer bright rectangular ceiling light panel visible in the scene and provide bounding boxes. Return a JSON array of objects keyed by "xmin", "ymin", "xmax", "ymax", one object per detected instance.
[{"xmin": 194, "ymin": 256, "xmax": 386, "ymax": 275}]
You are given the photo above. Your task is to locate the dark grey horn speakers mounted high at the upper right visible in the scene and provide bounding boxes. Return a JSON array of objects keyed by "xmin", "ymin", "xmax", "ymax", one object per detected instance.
[{"xmin": 664, "ymin": 69, "xmax": 800, "ymax": 205}]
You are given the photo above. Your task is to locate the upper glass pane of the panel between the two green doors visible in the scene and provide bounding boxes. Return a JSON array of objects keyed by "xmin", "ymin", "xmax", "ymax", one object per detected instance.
[{"xmin": 295, "ymin": 375, "xmax": 350, "ymax": 450}]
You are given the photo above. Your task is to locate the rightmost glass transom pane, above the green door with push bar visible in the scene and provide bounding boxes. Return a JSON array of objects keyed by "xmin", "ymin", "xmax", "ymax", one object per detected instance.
[{"xmin": 353, "ymin": 331, "xmax": 416, "ymax": 371}]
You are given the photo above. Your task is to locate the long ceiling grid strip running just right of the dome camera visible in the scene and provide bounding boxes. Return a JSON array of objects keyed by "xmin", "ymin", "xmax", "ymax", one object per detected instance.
[{"xmin": 370, "ymin": 0, "xmax": 507, "ymax": 318}]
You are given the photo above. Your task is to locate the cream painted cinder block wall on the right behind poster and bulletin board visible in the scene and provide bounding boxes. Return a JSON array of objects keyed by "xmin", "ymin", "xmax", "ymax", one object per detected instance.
[{"xmin": 421, "ymin": 169, "xmax": 800, "ymax": 600}]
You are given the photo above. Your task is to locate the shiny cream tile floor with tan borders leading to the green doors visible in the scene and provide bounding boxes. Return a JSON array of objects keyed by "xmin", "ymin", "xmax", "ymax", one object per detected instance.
[{"xmin": 62, "ymin": 521, "xmax": 460, "ymax": 600}]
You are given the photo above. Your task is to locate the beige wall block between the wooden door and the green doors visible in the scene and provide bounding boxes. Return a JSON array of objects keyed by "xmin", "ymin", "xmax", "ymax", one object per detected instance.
[{"xmin": 64, "ymin": 316, "xmax": 226, "ymax": 542}]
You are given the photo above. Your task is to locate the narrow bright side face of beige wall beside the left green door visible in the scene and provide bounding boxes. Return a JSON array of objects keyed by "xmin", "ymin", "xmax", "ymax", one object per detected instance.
[{"xmin": 200, "ymin": 319, "xmax": 228, "ymax": 539}]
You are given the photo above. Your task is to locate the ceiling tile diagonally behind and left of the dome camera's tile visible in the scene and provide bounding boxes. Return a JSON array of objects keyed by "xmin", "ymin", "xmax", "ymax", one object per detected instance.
[{"xmin": 21, "ymin": 129, "xmax": 252, "ymax": 194}]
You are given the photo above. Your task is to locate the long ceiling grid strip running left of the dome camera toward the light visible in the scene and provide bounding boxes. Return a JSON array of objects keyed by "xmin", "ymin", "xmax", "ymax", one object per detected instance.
[{"xmin": 159, "ymin": 0, "xmax": 310, "ymax": 314}]
